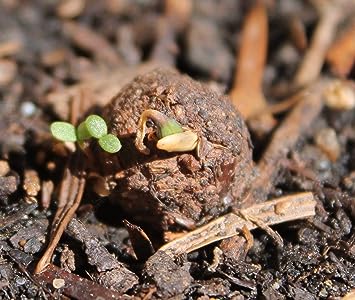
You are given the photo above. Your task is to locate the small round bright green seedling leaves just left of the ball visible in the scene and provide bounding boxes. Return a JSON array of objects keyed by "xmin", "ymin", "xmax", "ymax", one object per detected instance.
[{"xmin": 50, "ymin": 115, "xmax": 121, "ymax": 153}]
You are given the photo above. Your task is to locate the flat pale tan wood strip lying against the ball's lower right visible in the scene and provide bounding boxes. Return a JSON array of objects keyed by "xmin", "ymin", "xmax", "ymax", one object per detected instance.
[{"xmin": 159, "ymin": 192, "xmax": 316, "ymax": 257}]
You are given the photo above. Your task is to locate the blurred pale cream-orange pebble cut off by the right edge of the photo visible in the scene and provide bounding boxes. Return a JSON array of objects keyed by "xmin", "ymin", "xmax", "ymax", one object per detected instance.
[{"xmin": 324, "ymin": 80, "xmax": 355, "ymax": 110}]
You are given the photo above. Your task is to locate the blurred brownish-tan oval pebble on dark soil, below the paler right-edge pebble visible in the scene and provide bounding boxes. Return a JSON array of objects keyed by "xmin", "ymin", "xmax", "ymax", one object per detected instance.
[{"xmin": 315, "ymin": 128, "xmax": 341, "ymax": 161}]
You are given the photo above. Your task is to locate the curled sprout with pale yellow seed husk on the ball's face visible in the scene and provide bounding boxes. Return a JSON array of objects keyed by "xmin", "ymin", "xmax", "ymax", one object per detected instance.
[{"xmin": 135, "ymin": 109, "xmax": 199, "ymax": 155}]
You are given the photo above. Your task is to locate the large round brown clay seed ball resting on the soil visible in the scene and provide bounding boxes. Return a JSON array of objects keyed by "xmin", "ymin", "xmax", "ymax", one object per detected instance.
[{"xmin": 104, "ymin": 69, "xmax": 253, "ymax": 230}]
